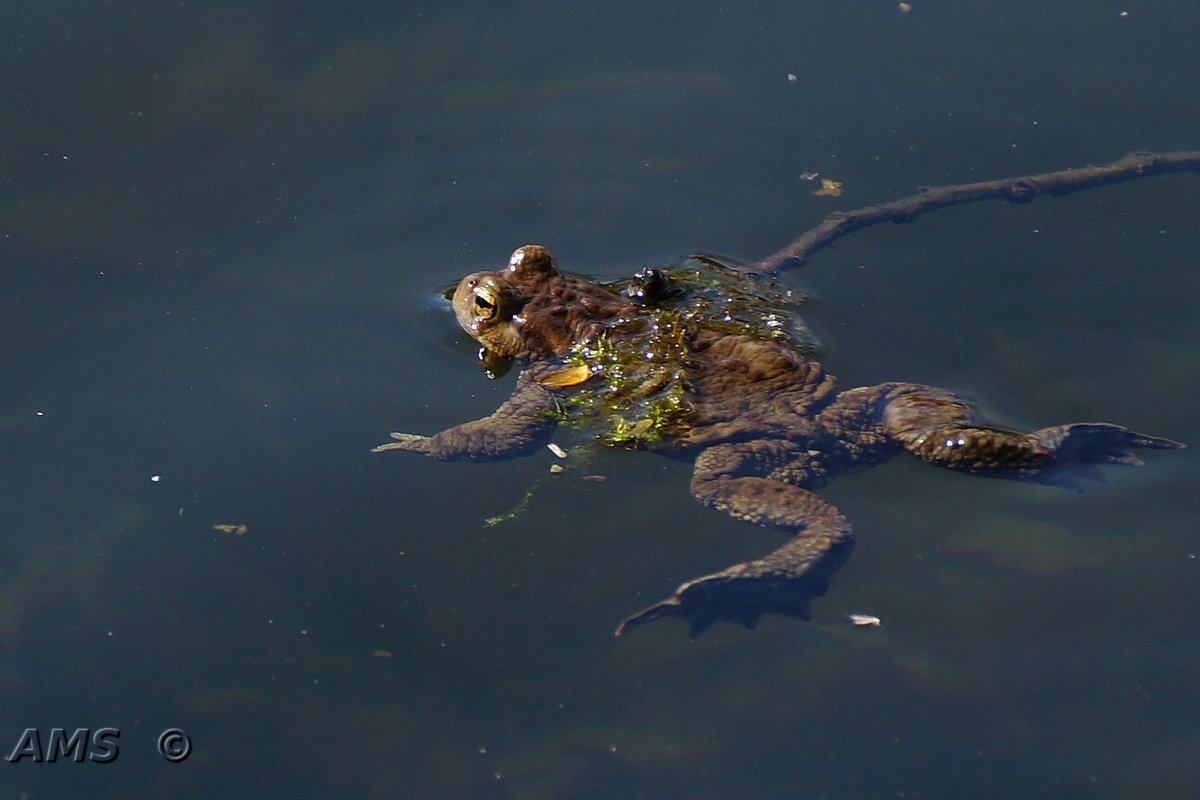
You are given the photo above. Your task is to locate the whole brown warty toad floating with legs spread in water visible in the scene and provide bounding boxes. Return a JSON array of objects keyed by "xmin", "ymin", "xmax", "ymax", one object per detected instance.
[{"xmin": 374, "ymin": 245, "xmax": 1183, "ymax": 636}]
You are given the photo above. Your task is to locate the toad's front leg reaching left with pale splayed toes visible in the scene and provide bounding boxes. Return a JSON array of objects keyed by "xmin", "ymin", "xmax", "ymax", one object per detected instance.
[{"xmin": 371, "ymin": 373, "xmax": 558, "ymax": 461}]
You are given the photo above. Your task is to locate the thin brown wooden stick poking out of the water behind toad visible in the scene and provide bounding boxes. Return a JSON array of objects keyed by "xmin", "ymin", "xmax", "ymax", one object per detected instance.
[{"xmin": 750, "ymin": 150, "xmax": 1200, "ymax": 273}]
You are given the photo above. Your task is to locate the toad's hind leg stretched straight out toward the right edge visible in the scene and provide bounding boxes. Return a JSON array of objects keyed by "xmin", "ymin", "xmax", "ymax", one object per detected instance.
[{"xmin": 854, "ymin": 384, "xmax": 1183, "ymax": 491}]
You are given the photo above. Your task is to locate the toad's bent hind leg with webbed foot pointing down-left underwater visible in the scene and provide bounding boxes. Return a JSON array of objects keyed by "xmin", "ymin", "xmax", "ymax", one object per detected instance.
[{"xmin": 617, "ymin": 443, "xmax": 854, "ymax": 638}]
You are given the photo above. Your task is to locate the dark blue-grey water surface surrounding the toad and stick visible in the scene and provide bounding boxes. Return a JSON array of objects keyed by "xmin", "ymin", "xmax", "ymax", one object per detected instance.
[{"xmin": 0, "ymin": 0, "xmax": 1200, "ymax": 800}]
